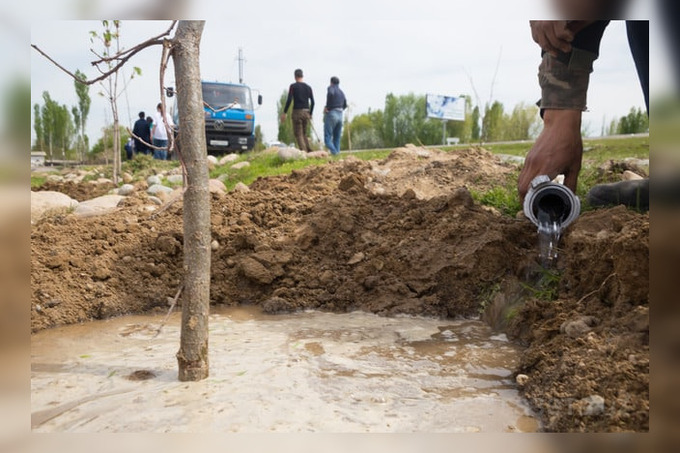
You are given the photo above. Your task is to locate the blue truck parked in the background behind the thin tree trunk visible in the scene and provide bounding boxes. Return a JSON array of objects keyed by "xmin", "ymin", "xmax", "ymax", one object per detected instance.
[{"xmin": 174, "ymin": 81, "xmax": 262, "ymax": 155}]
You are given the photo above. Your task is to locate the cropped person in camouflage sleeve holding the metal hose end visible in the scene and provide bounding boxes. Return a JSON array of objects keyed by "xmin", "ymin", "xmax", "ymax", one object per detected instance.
[{"xmin": 518, "ymin": 17, "xmax": 649, "ymax": 210}]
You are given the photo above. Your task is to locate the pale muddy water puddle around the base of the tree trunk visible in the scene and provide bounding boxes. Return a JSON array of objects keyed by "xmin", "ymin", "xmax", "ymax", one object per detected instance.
[{"xmin": 31, "ymin": 308, "xmax": 538, "ymax": 432}]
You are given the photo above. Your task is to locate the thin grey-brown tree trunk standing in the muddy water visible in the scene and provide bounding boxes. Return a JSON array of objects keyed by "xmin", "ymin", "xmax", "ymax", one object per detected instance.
[{"xmin": 172, "ymin": 21, "xmax": 210, "ymax": 381}]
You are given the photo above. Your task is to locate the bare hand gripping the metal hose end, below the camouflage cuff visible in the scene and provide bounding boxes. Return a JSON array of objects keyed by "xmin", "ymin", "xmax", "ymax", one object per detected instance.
[{"xmin": 517, "ymin": 109, "xmax": 583, "ymax": 202}]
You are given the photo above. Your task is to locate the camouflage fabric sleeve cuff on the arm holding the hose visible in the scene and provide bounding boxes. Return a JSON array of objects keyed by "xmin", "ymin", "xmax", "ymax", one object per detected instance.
[{"xmin": 538, "ymin": 48, "xmax": 597, "ymax": 113}]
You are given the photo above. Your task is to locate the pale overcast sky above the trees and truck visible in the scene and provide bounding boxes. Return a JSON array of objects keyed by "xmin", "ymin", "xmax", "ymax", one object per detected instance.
[{"xmin": 30, "ymin": 0, "xmax": 661, "ymax": 147}]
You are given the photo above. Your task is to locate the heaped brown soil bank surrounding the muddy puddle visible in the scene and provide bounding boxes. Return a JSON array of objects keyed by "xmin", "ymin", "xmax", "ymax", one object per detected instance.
[{"xmin": 31, "ymin": 148, "xmax": 649, "ymax": 431}]
